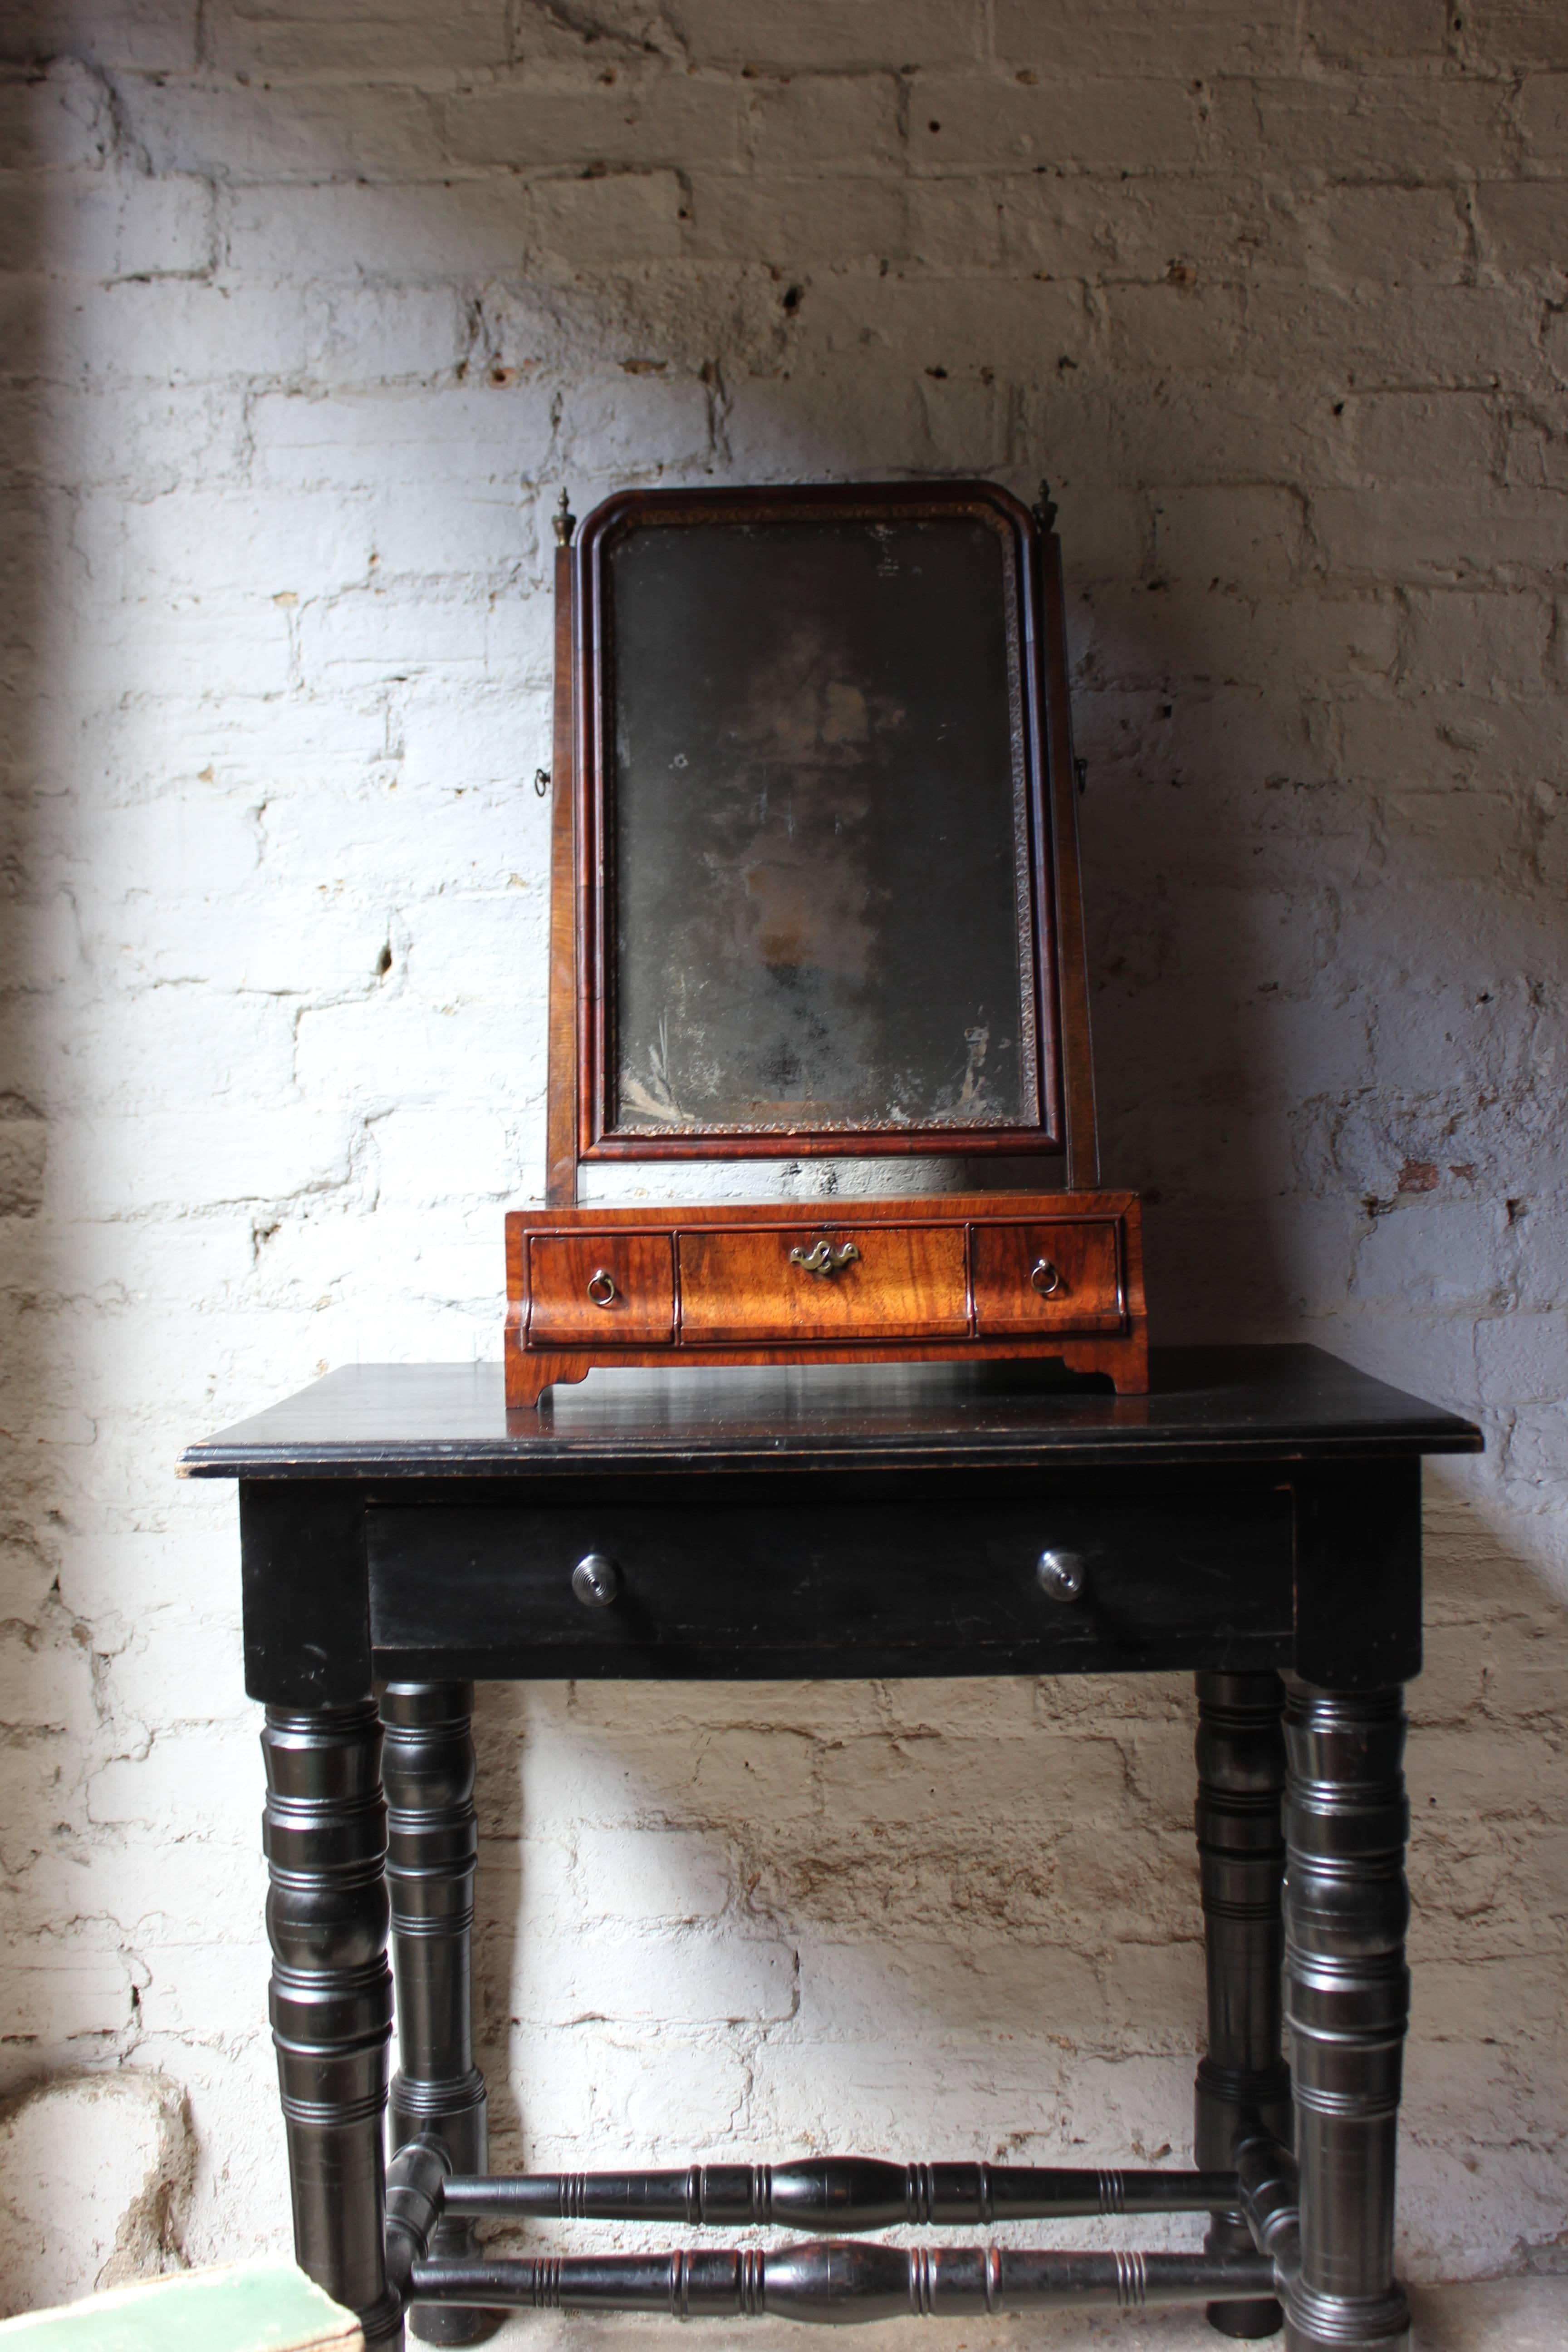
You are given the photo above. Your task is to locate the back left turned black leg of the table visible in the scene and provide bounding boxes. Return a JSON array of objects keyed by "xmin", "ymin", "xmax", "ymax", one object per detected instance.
[{"xmin": 381, "ymin": 1682, "xmax": 501, "ymax": 2345}]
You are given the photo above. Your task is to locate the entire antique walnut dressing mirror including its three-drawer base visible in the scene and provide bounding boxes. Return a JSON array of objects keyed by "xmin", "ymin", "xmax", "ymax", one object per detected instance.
[{"xmin": 505, "ymin": 482, "xmax": 1150, "ymax": 1411}]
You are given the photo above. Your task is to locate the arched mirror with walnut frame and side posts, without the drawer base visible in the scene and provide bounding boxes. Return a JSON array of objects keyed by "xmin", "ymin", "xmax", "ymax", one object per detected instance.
[{"xmin": 550, "ymin": 482, "xmax": 1096, "ymax": 1200}]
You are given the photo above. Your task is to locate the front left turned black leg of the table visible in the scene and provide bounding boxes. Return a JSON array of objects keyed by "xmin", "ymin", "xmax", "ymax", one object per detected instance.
[{"xmin": 261, "ymin": 1698, "xmax": 402, "ymax": 2352}]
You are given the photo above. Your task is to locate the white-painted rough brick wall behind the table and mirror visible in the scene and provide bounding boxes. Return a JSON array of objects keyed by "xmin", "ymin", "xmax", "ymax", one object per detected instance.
[{"xmin": 0, "ymin": 0, "xmax": 1568, "ymax": 2308}]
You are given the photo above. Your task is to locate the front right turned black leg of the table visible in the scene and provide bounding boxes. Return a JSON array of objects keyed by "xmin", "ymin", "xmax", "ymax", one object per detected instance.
[{"xmin": 1284, "ymin": 1679, "xmax": 1411, "ymax": 2352}]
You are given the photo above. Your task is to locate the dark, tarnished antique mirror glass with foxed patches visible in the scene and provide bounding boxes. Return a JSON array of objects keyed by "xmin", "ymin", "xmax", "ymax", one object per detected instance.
[{"xmin": 602, "ymin": 513, "xmax": 1039, "ymax": 1136}]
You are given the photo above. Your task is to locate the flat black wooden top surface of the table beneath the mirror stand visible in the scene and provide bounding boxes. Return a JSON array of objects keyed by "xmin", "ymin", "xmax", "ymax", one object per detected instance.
[{"xmin": 181, "ymin": 1348, "xmax": 1481, "ymax": 1480}]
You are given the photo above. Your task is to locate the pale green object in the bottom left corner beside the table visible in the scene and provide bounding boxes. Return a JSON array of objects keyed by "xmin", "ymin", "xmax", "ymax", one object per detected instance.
[{"xmin": 0, "ymin": 2263, "xmax": 364, "ymax": 2352}]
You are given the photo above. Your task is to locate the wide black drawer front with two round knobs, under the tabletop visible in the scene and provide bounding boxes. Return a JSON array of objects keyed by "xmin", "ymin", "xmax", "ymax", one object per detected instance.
[{"xmin": 367, "ymin": 1489, "xmax": 1293, "ymax": 1679}]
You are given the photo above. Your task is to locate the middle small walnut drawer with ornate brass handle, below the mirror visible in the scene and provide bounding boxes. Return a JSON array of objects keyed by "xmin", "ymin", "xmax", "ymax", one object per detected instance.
[{"xmin": 677, "ymin": 1225, "xmax": 969, "ymax": 1348}]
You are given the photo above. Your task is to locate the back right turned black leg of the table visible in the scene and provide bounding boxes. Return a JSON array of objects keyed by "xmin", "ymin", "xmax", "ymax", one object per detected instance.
[{"xmin": 1194, "ymin": 1675, "xmax": 1291, "ymax": 2338}]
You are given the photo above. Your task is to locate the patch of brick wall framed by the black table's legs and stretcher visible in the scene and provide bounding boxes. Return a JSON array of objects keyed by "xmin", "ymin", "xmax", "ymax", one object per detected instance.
[{"xmin": 465, "ymin": 1677, "xmax": 1204, "ymax": 2201}]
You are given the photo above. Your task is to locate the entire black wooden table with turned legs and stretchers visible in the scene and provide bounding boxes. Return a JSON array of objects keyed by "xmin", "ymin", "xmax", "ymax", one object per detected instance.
[{"xmin": 183, "ymin": 1348, "xmax": 1481, "ymax": 2352}]
